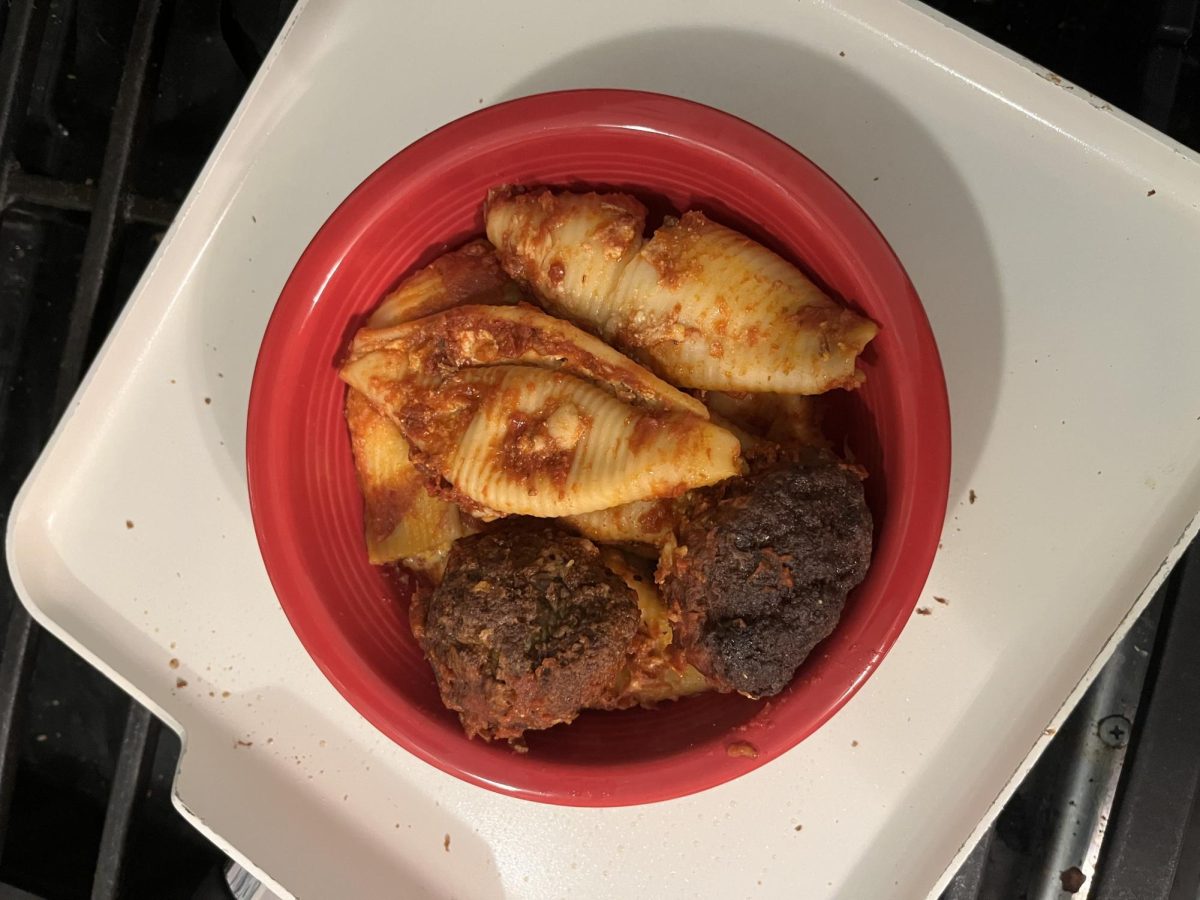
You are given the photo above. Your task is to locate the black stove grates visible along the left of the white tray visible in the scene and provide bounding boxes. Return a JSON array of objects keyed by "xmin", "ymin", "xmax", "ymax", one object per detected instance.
[{"xmin": 0, "ymin": 0, "xmax": 294, "ymax": 900}]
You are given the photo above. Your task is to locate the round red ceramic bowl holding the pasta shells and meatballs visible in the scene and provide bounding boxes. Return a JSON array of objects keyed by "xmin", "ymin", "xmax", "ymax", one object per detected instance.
[{"xmin": 246, "ymin": 90, "xmax": 950, "ymax": 806}]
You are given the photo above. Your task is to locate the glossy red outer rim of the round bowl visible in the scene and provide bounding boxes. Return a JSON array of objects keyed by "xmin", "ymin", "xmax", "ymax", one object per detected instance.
[{"xmin": 246, "ymin": 89, "xmax": 950, "ymax": 806}]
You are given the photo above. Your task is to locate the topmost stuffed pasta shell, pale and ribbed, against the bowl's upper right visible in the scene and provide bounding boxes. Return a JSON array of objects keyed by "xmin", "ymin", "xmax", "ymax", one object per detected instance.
[{"xmin": 486, "ymin": 190, "xmax": 876, "ymax": 394}]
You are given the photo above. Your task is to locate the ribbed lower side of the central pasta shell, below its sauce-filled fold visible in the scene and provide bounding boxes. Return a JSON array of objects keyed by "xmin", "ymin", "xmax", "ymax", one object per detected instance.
[{"xmin": 342, "ymin": 364, "xmax": 740, "ymax": 518}]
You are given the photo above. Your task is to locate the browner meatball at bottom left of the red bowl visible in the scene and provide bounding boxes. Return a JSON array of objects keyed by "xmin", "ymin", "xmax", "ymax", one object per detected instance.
[{"xmin": 414, "ymin": 521, "xmax": 640, "ymax": 739}]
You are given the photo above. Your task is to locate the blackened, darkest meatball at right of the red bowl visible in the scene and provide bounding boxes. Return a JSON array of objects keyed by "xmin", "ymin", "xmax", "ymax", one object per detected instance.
[{"xmin": 660, "ymin": 463, "xmax": 871, "ymax": 697}]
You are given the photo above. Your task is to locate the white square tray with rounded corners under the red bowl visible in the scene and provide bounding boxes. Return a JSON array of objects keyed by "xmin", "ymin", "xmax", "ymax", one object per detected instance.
[{"xmin": 8, "ymin": 0, "xmax": 1200, "ymax": 898}]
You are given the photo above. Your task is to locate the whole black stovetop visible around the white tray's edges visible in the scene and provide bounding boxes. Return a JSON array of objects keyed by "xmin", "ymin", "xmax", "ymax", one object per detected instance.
[{"xmin": 0, "ymin": 0, "xmax": 1200, "ymax": 900}]
